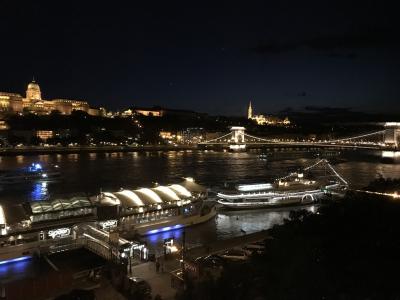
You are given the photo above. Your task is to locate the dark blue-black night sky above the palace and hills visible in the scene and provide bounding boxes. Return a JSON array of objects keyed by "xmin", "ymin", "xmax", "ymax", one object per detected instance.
[{"xmin": 0, "ymin": 0, "xmax": 400, "ymax": 115}]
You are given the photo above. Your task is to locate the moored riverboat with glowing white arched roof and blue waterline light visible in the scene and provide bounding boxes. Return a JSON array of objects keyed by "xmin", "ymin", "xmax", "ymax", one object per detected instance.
[{"xmin": 98, "ymin": 178, "xmax": 216, "ymax": 236}]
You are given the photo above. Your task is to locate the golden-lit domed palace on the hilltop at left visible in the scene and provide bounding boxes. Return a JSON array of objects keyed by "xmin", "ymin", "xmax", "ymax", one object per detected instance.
[{"xmin": 0, "ymin": 80, "xmax": 99, "ymax": 115}]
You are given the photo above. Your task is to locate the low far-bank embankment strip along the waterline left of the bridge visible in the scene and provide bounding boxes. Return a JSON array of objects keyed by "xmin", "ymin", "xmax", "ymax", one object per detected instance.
[{"xmin": 0, "ymin": 145, "xmax": 197, "ymax": 156}]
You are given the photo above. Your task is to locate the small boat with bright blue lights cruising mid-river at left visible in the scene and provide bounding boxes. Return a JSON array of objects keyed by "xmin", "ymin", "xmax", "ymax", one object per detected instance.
[{"xmin": 0, "ymin": 163, "xmax": 61, "ymax": 185}]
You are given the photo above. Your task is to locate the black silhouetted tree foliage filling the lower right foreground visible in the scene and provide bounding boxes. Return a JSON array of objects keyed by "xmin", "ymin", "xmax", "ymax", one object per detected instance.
[{"xmin": 177, "ymin": 193, "xmax": 400, "ymax": 300}]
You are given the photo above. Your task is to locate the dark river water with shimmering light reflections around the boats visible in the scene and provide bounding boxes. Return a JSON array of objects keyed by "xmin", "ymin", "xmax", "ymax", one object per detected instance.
[{"xmin": 0, "ymin": 150, "xmax": 400, "ymax": 251}]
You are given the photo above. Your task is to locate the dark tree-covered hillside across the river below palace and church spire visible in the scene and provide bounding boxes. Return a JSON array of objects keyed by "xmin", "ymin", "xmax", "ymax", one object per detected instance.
[{"xmin": 1, "ymin": 111, "xmax": 382, "ymax": 145}]
